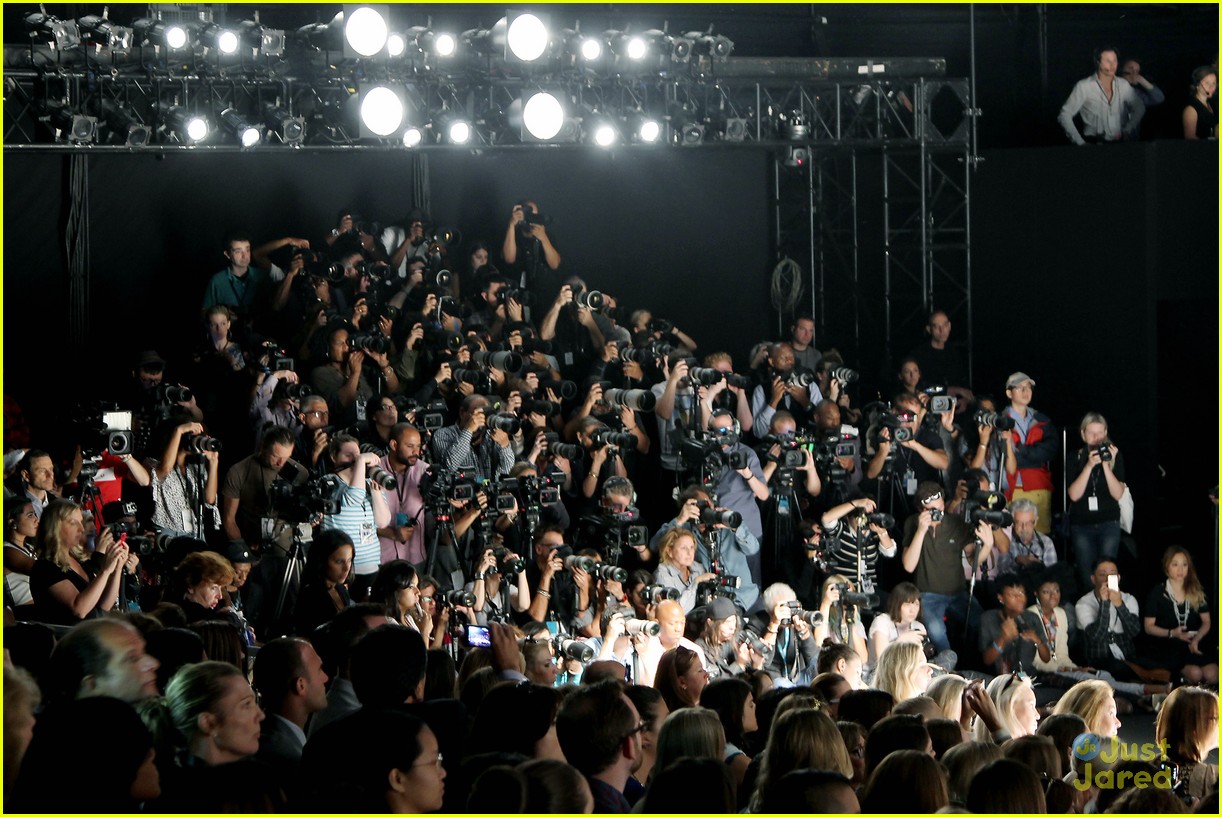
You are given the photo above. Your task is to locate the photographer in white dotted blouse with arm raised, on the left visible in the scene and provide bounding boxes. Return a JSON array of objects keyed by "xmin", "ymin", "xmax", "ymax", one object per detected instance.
[{"xmin": 152, "ymin": 409, "xmax": 220, "ymax": 539}]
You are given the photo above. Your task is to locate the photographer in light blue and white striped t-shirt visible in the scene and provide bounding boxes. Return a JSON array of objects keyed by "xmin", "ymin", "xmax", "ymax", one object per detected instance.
[{"xmin": 319, "ymin": 434, "xmax": 391, "ymax": 601}]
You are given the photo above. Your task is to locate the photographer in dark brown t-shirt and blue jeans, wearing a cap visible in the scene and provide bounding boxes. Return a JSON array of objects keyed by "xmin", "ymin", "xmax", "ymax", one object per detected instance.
[{"xmin": 902, "ymin": 482, "xmax": 993, "ymax": 652}]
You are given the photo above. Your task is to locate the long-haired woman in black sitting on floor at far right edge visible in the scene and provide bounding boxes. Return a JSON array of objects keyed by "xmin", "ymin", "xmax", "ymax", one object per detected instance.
[{"xmin": 1141, "ymin": 545, "xmax": 1218, "ymax": 684}]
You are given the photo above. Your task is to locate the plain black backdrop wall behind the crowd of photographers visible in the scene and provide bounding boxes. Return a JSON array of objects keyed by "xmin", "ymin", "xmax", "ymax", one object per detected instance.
[{"xmin": 4, "ymin": 142, "xmax": 1218, "ymax": 593}]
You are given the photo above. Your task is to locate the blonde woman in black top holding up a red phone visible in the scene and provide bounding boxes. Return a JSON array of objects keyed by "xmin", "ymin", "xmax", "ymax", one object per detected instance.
[{"xmin": 29, "ymin": 499, "xmax": 131, "ymax": 625}]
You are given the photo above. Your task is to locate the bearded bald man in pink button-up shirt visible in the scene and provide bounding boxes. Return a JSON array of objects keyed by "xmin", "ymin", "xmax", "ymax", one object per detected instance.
[{"xmin": 378, "ymin": 423, "xmax": 429, "ymax": 564}]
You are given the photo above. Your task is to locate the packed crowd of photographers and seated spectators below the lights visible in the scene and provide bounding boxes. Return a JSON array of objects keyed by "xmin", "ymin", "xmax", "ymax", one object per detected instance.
[{"xmin": 4, "ymin": 195, "xmax": 1217, "ymax": 813}]
